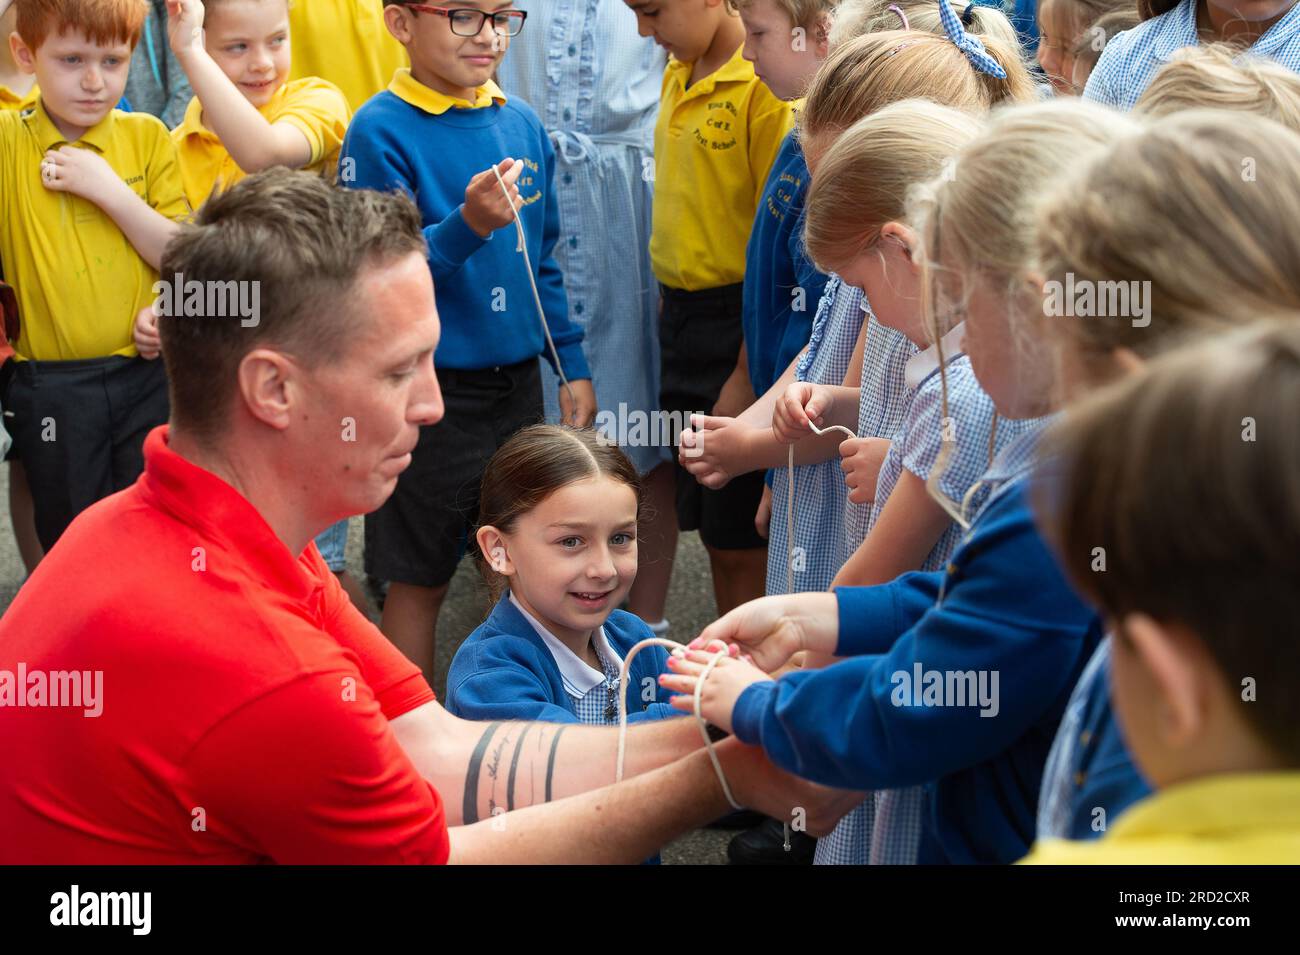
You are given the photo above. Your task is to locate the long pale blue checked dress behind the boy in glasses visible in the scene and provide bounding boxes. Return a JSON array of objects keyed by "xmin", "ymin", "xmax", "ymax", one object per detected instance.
[{"xmin": 498, "ymin": 0, "xmax": 671, "ymax": 474}]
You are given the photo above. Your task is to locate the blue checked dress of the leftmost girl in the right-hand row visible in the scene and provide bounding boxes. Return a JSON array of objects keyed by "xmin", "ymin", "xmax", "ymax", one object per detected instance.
[{"xmin": 767, "ymin": 273, "xmax": 866, "ymax": 594}]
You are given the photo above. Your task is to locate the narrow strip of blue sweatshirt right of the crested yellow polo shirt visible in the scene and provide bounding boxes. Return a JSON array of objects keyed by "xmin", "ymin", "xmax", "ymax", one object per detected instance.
[{"xmin": 741, "ymin": 130, "xmax": 829, "ymax": 395}]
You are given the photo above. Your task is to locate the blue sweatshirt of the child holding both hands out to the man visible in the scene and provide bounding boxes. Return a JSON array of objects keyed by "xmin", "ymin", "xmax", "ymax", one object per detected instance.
[{"xmin": 732, "ymin": 478, "xmax": 1101, "ymax": 863}]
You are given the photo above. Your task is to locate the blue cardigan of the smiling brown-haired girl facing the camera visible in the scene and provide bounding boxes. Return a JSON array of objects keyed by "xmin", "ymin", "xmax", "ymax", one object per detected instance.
[{"xmin": 445, "ymin": 594, "xmax": 679, "ymax": 722}]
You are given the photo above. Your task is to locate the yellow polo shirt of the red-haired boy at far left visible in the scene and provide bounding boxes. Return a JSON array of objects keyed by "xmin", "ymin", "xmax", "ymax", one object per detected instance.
[{"xmin": 0, "ymin": 101, "xmax": 190, "ymax": 361}]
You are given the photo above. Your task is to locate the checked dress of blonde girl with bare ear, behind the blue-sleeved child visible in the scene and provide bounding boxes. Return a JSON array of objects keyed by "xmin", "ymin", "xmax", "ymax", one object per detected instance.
[{"xmin": 815, "ymin": 355, "xmax": 1043, "ymax": 865}]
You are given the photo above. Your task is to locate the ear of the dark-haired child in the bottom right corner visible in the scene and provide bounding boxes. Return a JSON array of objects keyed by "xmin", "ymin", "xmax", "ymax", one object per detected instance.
[{"xmin": 1121, "ymin": 613, "xmax": 1213, "ymax": 750}]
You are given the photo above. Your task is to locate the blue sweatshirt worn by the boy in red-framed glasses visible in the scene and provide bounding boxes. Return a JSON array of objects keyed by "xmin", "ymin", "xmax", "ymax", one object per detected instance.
[{"xmin": 339, "ymin": 81, "xmax": 592, "ymax": 381}]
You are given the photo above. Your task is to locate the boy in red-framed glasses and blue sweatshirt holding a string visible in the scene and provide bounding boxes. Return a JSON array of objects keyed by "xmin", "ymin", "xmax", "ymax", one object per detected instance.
[{"xmin": 339, "ymin": 0, "xmax": 595, "ymax": 677}]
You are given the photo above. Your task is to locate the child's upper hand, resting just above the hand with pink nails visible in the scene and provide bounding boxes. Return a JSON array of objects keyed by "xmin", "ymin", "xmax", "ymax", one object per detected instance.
[{"xmin": 688, "ymin": 592, "xmax": 840, "ymax": 673}]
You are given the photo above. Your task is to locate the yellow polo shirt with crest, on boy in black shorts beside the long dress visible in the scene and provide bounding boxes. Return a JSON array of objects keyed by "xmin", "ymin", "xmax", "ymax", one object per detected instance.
[{"xmin": 650, "ymin": 49, "xmax": 794, "ymax": 291}]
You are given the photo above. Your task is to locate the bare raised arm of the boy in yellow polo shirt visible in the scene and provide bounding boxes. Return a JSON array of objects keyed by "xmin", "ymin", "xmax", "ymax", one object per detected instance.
[{"xmin": 166, "ymin": 0, "xmax": 312, "ymax": 173}]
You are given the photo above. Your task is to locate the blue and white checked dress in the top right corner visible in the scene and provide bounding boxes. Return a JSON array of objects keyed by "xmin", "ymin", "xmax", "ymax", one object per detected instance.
[{"xmin": 1083, "ymin": 0, "xmax": 1300, "ymax": 110}]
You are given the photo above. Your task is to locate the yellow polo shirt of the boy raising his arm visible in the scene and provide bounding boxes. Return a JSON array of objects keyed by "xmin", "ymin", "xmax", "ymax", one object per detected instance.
[{"xmin": 172, "ymin": 77, "xmax": 352, "ymax": 209}]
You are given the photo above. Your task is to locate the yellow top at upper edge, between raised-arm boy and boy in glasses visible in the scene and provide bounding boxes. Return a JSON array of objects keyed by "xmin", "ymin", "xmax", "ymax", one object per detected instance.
[{"xmin": 289, "ymin": 0, "xmax": 408, "ymax": 113}]
